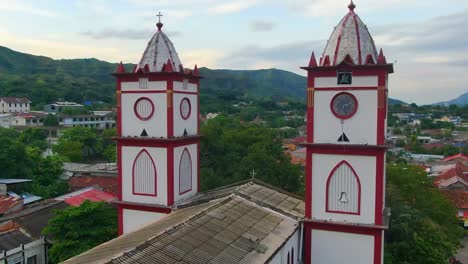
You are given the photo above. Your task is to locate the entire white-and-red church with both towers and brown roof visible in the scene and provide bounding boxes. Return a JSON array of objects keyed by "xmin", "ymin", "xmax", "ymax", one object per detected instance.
[{"xmin": 64, "ymin": 2, "xmax": 393, "ymax": 264}]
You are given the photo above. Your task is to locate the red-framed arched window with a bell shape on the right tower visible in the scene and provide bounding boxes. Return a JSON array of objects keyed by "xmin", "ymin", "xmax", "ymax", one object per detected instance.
[{"xmin": 326, "ymin": 160, "xmax": 361, "ymax": 214}]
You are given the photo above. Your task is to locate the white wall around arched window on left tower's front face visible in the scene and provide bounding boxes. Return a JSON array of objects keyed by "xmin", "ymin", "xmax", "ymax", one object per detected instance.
[{"xmin": 122, "ymin": 147, "xmax": 167, "ymax": 205}]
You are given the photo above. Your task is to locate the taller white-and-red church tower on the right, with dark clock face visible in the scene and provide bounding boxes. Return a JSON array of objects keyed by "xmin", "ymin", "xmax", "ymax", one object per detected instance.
[{"xmin": 303, "ymin": 2, "xmax": 393, "ymax": 264}]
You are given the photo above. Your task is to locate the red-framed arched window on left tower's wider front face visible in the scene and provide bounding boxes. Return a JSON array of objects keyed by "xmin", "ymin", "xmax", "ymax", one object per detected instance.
[{"xmin": 133, "ymin": 149, "xmax": 157, "ymax": 196}]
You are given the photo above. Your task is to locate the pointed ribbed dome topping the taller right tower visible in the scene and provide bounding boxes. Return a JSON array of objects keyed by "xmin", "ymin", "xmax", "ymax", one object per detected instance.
[{"xmin": 320, "ymin": 1, "xmax": 377, "ymax": 66}]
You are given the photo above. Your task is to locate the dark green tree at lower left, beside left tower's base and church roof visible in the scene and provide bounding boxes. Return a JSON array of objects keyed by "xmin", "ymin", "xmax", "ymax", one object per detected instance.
[{"xmin": 42, "ymin": 201, "xmax": 117, "ymax": 263}]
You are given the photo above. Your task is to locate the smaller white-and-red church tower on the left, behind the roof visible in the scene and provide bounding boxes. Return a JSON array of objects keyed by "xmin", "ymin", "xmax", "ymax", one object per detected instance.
[{"xmin": 114, "ymin": 14, "xmax": 200, "ymax": 234}]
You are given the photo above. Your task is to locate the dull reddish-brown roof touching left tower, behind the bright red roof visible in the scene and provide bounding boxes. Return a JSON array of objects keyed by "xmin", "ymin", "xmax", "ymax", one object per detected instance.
[{"xmin": 68, "ymin": 176, "xmax": 118, "ymax": 195}]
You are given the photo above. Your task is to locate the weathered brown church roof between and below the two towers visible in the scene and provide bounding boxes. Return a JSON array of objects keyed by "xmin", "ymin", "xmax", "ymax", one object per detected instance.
[{"xmin": 64, "ymin": 181, "xmax": 304, "ymax": 264}]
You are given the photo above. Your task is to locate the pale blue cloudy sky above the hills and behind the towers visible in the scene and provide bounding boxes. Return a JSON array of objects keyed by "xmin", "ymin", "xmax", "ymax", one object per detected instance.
[{"xmin": 0, "ymin": 0, "xmax": 468, "ymax": 105}]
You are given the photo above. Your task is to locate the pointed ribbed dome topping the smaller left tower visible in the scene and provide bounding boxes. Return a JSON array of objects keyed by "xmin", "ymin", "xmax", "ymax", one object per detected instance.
[{"xmin": 135, "ymin": 18, "xmax": 182, "ymax": 72}]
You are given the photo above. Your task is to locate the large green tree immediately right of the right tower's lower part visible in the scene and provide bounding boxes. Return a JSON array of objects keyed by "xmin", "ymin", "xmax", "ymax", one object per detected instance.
[{"xmin": 385, "ymin": 164, "xmax": 463, "ymax": 264}]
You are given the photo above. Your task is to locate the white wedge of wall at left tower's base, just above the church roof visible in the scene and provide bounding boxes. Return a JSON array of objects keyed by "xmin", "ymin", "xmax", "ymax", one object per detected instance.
[{"xmin": 123, "ymin": 209, "xmax": 167, "ymax": 234}]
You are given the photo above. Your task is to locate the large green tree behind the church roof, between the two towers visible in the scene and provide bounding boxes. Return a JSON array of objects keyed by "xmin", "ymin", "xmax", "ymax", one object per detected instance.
[{"xmin": 200, "ymin": 116, "xmax": 303, "ymax": 193}]
